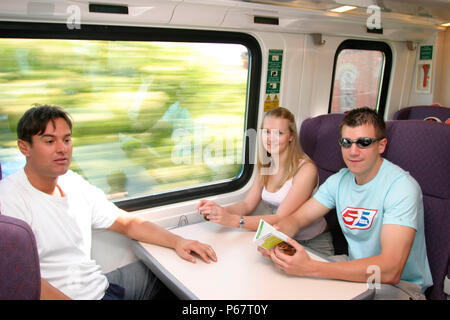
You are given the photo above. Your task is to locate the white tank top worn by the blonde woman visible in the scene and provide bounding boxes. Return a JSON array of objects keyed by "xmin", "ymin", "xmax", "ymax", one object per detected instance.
[{"xmin": 261, "ymin": 163, "xmax": 327, "ymax": 240}]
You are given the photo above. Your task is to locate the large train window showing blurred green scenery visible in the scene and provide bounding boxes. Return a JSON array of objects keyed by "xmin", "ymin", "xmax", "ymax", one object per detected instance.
[{"xmin": 0, "ymin": 24, "xmax": 260, "ymax": 210}]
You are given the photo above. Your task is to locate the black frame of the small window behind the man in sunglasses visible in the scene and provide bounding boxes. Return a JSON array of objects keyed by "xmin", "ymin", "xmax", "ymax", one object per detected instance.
[{"xmin": 328, "ymin": 39, "xmax": 392, "ymax": 116}]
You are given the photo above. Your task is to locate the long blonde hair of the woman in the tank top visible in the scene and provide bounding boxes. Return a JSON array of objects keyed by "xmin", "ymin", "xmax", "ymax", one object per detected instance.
[{"xmin": 257, "ymin": 107, "xmax": 311, "ymax": 189}]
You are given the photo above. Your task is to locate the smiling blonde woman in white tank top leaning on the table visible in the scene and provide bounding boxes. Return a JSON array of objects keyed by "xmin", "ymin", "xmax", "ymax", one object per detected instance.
[{"xmin": 197, "ymin": 107, "xmax": 334, "ymax": 255}]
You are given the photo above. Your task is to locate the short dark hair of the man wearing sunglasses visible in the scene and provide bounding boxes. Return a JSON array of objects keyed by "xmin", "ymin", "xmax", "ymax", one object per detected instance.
[{"xmin": 339, "ymin": 107, "xmax": 386, "ymax": 138}]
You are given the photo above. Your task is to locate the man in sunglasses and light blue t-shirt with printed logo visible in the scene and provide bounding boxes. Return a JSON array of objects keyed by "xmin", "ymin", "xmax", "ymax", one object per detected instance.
[{"xmin": 259, "ymin": 108, "xmax": 432, "ymax": 299}]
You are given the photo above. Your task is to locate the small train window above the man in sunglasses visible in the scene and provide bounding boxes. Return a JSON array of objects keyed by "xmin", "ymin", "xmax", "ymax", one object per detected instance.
[{"xmin": 329, "ymin": 40, "xmax": 392, "ymax": 114}]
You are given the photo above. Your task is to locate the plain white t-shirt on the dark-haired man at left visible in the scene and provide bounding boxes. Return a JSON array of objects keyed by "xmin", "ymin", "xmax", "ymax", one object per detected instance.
[{"xmin": 0, "ymin": 170, "xmax": 123, "ymax": 300}]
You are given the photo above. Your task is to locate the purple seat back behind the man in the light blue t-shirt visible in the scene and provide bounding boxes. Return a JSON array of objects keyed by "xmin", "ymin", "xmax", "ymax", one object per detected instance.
[{"xmin": 383, "ymin": 120, "xmax": 450, "ymax": 299}]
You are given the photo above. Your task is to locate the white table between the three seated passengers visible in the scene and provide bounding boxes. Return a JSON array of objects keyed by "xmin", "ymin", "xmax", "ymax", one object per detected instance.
[{"xmin": 133, "ymin": 222, "xmax": 373, "ymax": 300}]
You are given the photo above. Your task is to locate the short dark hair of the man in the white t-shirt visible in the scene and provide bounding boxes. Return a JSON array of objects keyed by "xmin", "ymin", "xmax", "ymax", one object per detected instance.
[{"xmin": 17, "ymin": 104, "xmax": 72, "ymax": 144}]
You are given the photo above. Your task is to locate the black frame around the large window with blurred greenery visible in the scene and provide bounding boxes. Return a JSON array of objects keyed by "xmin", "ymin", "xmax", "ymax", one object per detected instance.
[{"xmin": 0, "ymin": 21, "xmax": 262, "ymax": 212}]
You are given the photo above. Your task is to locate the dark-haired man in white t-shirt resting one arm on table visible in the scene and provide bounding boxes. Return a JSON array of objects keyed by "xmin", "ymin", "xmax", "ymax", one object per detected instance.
[{"xmin": 0, "ymin": 106, "xmax": 217, "ymax": 299}]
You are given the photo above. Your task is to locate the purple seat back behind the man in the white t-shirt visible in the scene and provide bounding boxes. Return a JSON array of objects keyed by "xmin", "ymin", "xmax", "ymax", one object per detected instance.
[{"xmin": 0, "ymin": 165, "xmax": 41, "ymax": 300}]
